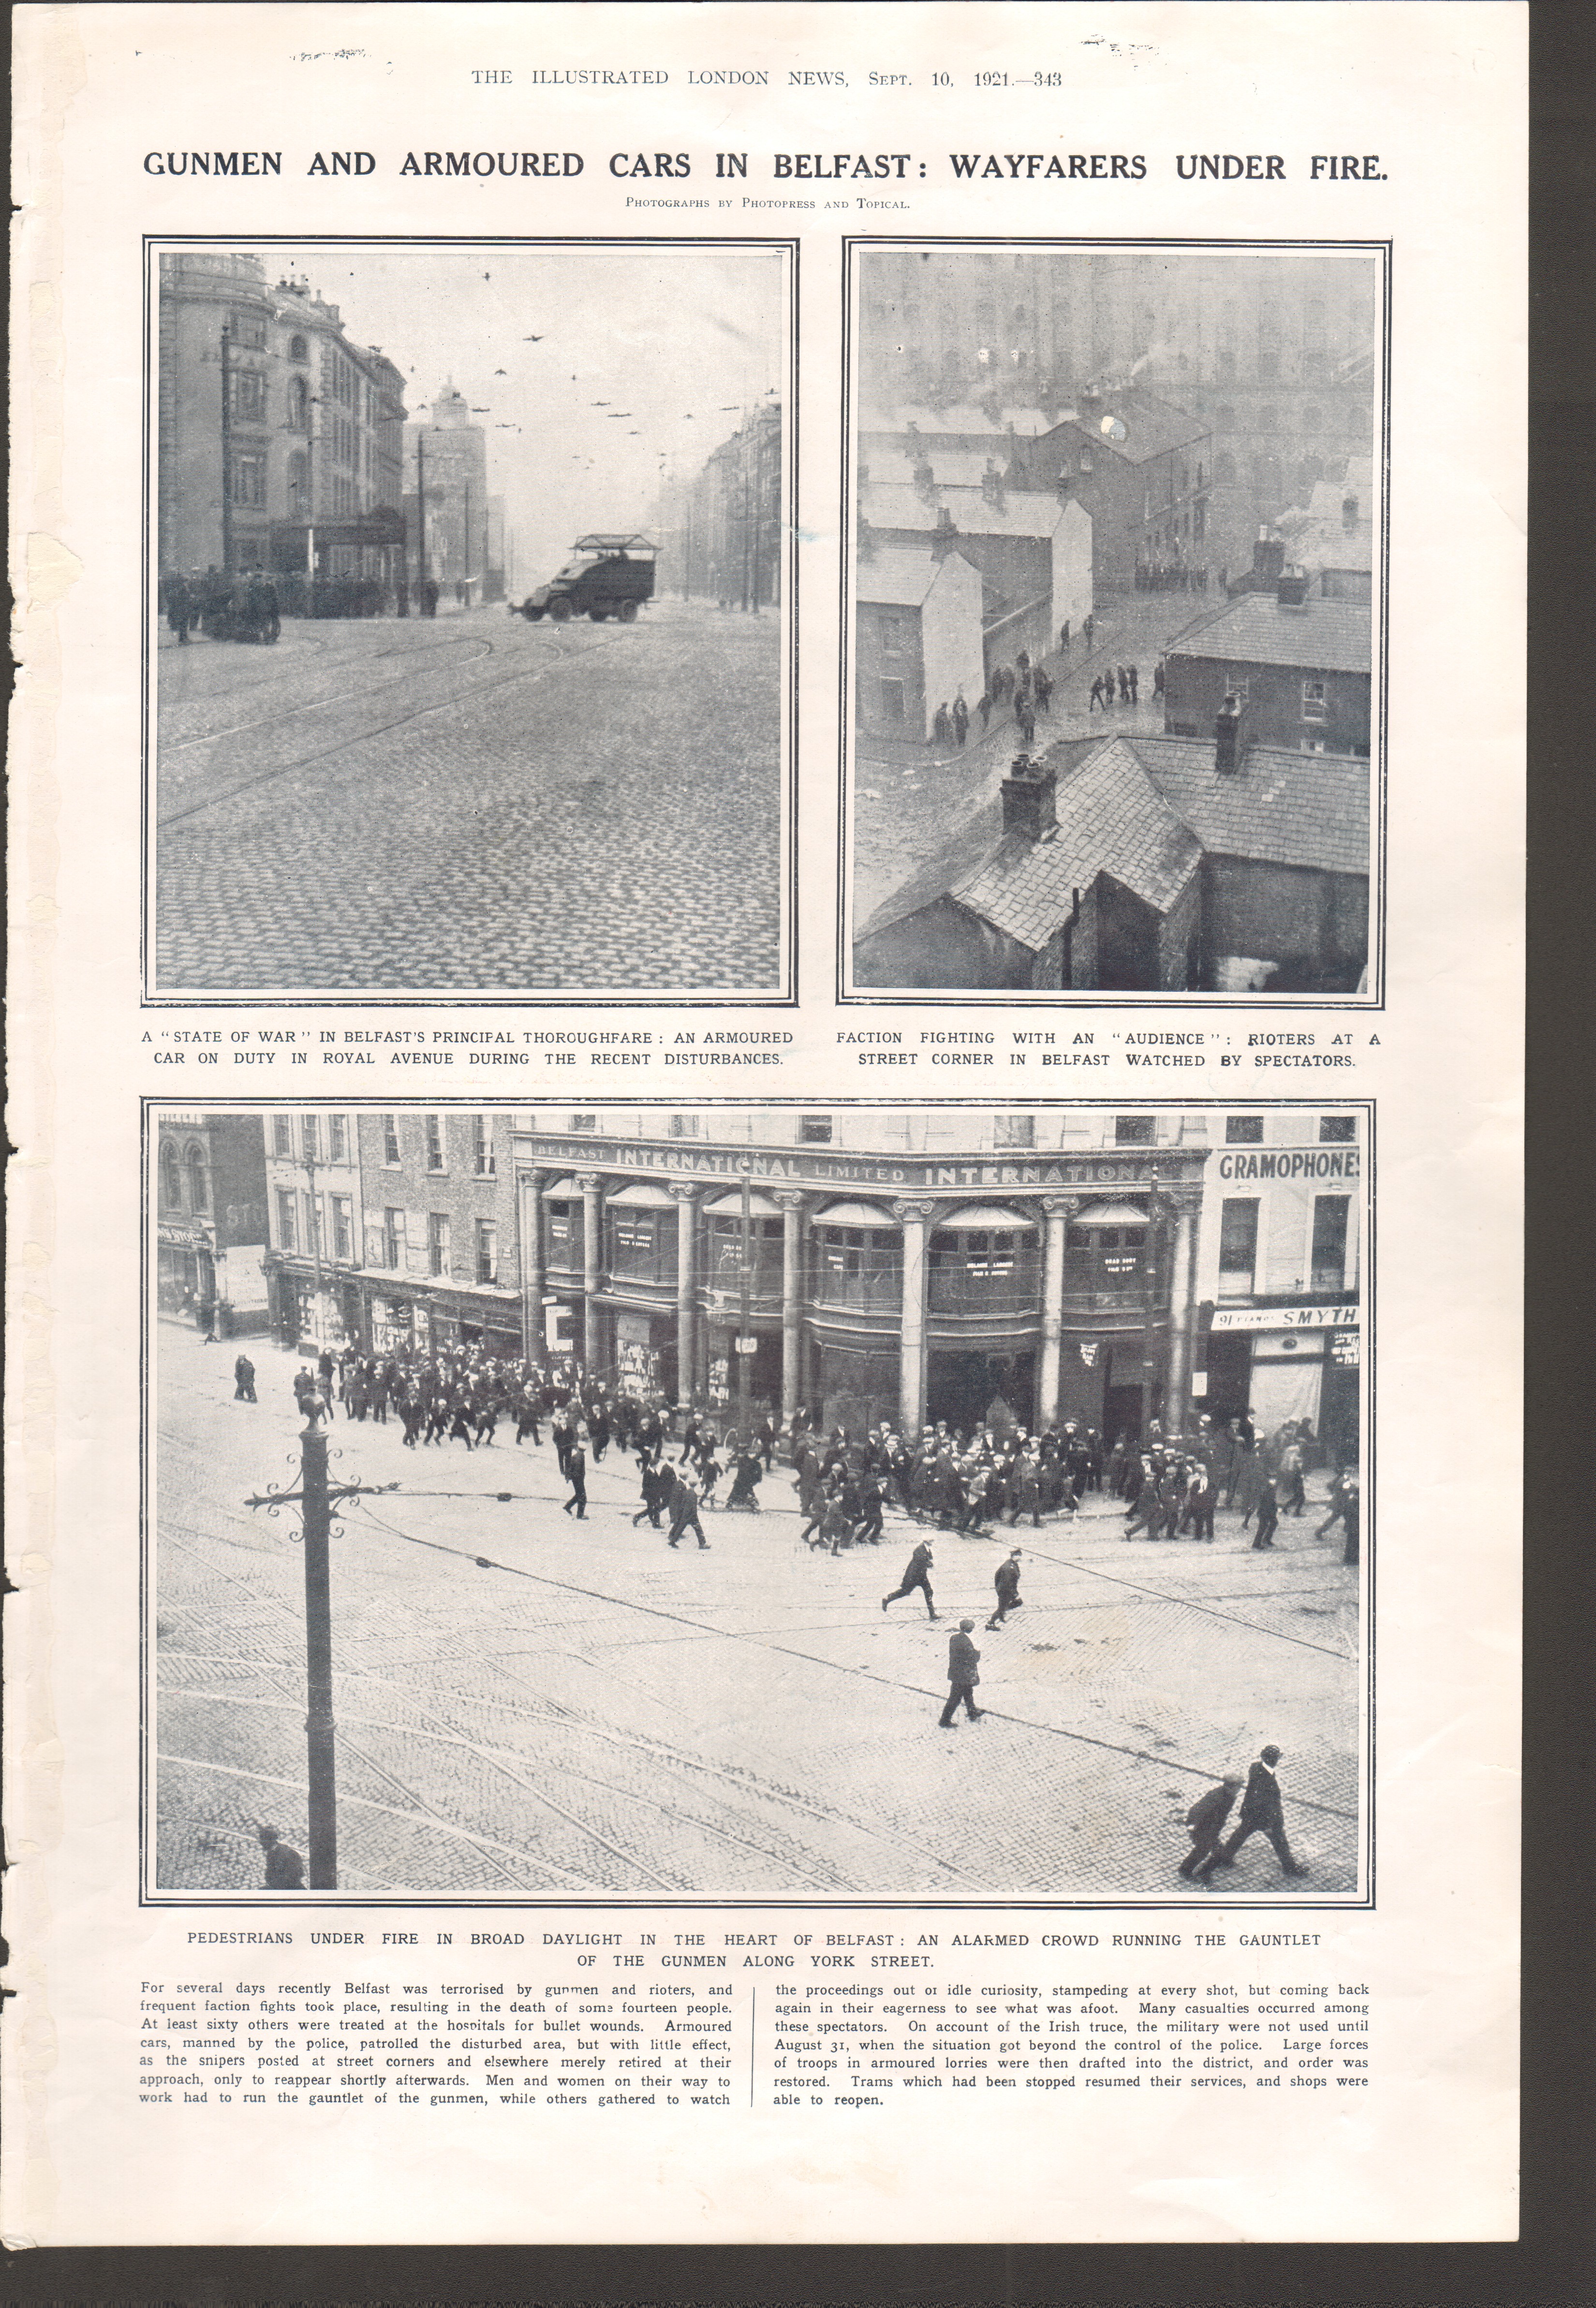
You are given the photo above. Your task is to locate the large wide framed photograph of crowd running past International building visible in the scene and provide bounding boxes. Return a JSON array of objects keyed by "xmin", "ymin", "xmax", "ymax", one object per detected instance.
[{"xmin": 143, "ymin": 1101, "xmax": 1372, "ymax": 1909}]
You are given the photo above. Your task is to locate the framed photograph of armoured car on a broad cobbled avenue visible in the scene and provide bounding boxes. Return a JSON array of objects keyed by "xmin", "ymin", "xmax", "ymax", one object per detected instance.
[{"xmin": 145, "ymin": 238, "xmax": 796, "ymax": 1004}]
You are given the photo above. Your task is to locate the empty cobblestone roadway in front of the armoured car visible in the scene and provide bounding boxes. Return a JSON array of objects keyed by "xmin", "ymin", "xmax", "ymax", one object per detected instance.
[{"xmin": 155, "ymin": 600, "xmax": 782, "ymax": 993}]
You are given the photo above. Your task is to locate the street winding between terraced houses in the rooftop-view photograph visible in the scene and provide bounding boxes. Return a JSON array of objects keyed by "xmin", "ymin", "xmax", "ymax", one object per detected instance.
[{"xmin": 853, "ymin": 591, "xmax": 1225, "ymax": 928}]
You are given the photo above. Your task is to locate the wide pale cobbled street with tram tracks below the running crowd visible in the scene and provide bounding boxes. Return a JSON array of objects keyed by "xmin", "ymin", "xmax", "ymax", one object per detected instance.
[{"xmin": 152, "ymin": 1320, "xmax": 1359, "ymax": 1906}]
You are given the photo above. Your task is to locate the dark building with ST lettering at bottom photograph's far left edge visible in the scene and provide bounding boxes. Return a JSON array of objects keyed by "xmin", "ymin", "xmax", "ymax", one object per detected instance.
[{"xmin": 155, "ymin": 1113, "xmax": 267, "ymax": 1339}]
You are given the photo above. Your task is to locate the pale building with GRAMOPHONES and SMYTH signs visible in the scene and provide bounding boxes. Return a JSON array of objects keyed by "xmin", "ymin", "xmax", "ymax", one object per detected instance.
[{"xmin": 1197, "ymin": 1108, "xmax": 1368, "ymax": 1463}]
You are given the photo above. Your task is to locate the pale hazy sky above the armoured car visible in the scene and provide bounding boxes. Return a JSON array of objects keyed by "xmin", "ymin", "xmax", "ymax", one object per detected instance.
[{"xmin": 273, "ymin": 242, "xmax": 784, "ymax": 589}]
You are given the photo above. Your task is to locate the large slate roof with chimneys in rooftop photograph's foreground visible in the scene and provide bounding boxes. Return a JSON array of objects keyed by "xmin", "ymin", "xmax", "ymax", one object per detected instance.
[{"xmin": 860, "ymin": 736, "xmax": 1370, "ymax": 953}]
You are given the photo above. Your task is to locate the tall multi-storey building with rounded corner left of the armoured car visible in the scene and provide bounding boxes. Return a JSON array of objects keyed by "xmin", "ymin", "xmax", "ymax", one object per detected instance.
[{"xmin": 157, "ymin": 249, "xmax": 404, "ymax": 591}]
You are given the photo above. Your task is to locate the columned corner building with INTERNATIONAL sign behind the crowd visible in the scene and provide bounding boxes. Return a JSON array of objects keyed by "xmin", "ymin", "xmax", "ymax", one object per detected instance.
[{"xmin": 514, "ymin": 1108, "xmax": 1222, "ymax": 1433}]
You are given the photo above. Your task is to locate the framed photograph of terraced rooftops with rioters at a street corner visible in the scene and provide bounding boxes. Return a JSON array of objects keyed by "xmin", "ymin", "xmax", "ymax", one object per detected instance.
[{"xmin": 840, "ymin": 240, "xmax": 1389, "ymax": 1006}]
